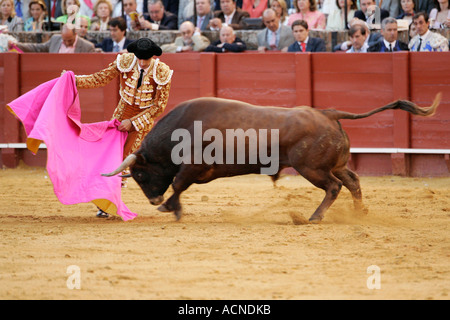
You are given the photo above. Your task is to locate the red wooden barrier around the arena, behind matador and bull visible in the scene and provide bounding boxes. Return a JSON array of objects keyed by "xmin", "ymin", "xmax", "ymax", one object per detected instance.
[{"xmin": 0, "ymin": 52, "xmax": 450, "ymax": 175}]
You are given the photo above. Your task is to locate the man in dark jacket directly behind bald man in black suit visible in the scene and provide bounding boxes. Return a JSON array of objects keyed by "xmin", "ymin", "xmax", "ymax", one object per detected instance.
[{"xmin": 209, "ymin": 0, "xmax": 250, "ymax": 30}]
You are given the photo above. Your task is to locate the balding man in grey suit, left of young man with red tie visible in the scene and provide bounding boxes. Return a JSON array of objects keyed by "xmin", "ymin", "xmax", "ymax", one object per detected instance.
[{"xmin": 257, "ymin": 9, "xmax": 295, "ymax": 52}]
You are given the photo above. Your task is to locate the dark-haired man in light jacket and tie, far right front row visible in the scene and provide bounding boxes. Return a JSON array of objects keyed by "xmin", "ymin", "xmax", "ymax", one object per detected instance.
[{"xmin": 409, "ymin": 12, "xmax": 448, "ymax": 51}]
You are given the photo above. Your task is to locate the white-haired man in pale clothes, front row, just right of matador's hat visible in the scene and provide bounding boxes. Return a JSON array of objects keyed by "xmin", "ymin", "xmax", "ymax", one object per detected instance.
[{"xmin": 161, "ymin": 21, "xmax": 210, "ymax": 53}]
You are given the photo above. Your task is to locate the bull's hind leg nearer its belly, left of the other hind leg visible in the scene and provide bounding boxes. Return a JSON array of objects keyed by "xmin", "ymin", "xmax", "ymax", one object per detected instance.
[{"xmin": 296, "ymin": 168, "xmax": 342, "ymax": 223}]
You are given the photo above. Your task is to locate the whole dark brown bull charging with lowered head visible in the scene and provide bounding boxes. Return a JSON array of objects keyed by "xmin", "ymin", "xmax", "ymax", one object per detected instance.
[{"xmin": 105, "ymin": 94, "xmax": 440, "ymax": 222}]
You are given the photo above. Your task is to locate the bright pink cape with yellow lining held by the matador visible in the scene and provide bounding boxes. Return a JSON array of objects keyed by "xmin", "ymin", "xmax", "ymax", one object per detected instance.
[{"xmin": 7, "ymin": 71, "xmax": 136, "ymax": 220}]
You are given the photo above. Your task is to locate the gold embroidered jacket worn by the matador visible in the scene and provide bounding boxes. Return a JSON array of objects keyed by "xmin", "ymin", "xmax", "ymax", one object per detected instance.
[{"xmin": 76, "ymin": 53, "xmax": 173, "ymax": 152}]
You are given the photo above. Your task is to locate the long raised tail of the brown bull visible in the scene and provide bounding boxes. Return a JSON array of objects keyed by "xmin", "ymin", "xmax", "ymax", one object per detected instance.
[{"xmin": 322, "ymin": 93, "xmax": 442, "ymax": 120}]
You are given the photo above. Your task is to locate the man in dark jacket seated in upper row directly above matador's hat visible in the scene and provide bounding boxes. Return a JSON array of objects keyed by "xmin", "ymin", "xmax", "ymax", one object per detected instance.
[{"xmin": 134, "ymin": 0, "xmax": 178, "ymax": 31}]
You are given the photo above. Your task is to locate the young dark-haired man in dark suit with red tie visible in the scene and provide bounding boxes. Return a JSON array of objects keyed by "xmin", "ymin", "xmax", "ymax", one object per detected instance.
[{"xmin": 288, "ymin": 20, "xmax": 327, "ymax": 52}]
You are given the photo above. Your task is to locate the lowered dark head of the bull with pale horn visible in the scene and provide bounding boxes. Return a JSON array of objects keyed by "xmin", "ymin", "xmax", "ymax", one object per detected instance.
[{"xmin": 102, "ymin": 153, "xmax": 173, "ymax": 205}]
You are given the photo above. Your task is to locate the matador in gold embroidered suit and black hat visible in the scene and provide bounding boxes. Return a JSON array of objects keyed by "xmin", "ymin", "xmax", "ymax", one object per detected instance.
[{"xmin": 76, "ymin": 38, "xmax": 173, "ymax": 217}]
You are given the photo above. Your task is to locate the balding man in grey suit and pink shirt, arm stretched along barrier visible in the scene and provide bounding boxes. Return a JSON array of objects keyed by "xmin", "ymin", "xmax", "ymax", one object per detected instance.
[{"xmin": 12, "ymin": 25, "xmax": 94, "ymax": 53}]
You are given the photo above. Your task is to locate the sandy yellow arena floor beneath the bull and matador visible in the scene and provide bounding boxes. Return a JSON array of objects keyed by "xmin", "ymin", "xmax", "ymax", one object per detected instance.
[{"xmin": 0, "ymin": 166, "xmax": 450, "ymax": 300}]
